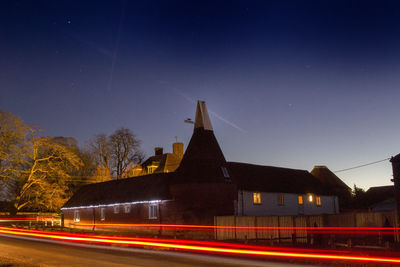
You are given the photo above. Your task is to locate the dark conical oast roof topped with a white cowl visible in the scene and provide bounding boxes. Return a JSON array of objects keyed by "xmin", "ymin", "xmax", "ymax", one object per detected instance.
[{"xmin": 177, "ymin": 101, "xmax": 229, "ymax": 182}]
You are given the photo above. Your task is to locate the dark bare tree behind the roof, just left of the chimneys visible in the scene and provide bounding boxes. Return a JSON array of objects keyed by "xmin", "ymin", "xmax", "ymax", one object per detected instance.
[{"xmin": 109, "ymin": 128, "xmax": 144, "ymax": 179}]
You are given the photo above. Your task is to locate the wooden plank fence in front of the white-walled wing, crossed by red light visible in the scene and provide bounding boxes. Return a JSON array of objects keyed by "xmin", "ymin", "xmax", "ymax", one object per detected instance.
[{"xmin": 214, "ymin": 211, "xmax": 400, "ymax": 245}]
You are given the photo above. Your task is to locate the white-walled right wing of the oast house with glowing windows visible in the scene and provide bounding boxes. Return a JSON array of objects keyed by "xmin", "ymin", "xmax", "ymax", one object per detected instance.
[{"xmin": 228, "ymin": 162, "xmax": 339, "ymax": 216}]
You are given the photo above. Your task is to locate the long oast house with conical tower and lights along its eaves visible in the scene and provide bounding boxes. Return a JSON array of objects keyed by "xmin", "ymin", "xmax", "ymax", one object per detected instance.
[{"xmin": 62, "ymin": 101, "xmax": 339, "ymax": 234}]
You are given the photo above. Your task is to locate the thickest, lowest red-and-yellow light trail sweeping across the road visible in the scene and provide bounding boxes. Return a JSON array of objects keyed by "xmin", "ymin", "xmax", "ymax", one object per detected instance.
[{"xmin": 0, "ymin": 227, "xmax": 400, "ymax": 264}]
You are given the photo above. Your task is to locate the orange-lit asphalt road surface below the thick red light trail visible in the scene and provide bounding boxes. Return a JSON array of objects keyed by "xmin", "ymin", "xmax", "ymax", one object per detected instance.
[{"xmin": 0, "ymin": 235, "xmax": 315, "ymax": 267}]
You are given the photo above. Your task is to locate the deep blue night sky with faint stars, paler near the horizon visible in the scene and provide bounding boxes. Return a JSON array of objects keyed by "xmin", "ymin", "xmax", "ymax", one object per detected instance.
[{"xmin": 0, "ymin": 0, "xmax": 400, "ymax": 189}]
